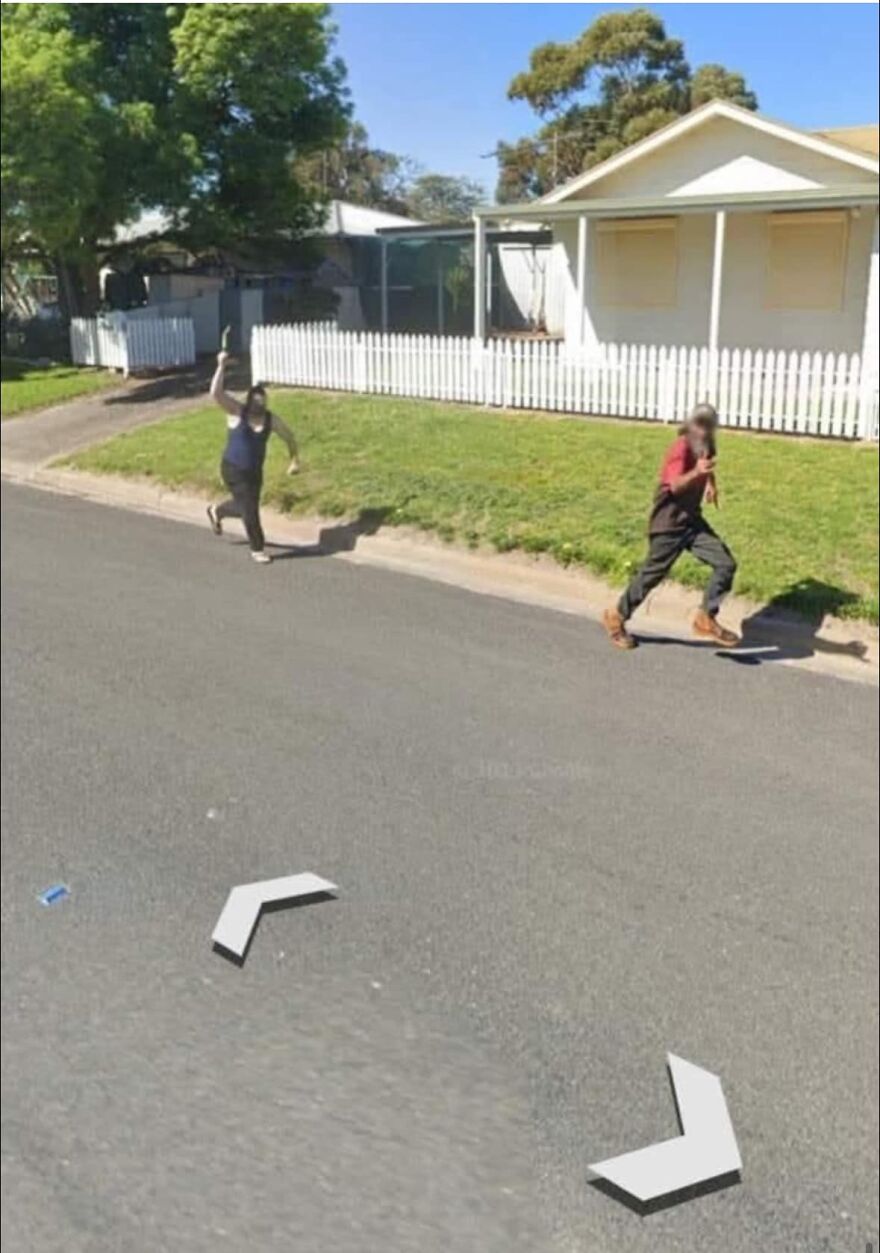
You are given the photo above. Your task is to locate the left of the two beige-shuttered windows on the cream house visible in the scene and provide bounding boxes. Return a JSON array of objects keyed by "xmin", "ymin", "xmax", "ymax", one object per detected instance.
[{"xmin": 595, "ymin": 218, "xmax": 678, "ymax": 308}]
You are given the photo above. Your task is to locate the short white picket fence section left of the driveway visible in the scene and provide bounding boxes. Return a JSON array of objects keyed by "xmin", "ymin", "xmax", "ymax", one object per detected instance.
[{"xmin": 70, "ymin": 313, "xmax": 196, "ymax": 375}]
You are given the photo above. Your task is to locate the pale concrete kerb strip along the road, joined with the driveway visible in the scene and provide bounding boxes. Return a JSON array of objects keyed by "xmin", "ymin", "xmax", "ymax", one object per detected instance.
[{"xmin": 0, "ymin": 373, "xmax": 880, "ymax": 684}]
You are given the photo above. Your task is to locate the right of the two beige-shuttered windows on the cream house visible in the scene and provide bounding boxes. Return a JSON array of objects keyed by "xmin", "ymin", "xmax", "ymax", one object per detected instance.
[{"xmin": 765, "ymin": 209, "xmax": 849, "ymax": 309}]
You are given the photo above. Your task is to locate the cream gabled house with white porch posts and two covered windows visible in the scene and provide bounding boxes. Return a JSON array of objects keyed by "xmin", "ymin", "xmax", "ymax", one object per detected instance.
[{"xmin": 474, "ymin": 100, "xmax": 879, "ymax": 378}]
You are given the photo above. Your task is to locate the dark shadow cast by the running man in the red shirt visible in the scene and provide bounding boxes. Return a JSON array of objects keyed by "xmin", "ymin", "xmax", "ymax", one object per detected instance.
[{"xmin": 718, "ymin": 579, "xmax": 867, "ymax": 665}]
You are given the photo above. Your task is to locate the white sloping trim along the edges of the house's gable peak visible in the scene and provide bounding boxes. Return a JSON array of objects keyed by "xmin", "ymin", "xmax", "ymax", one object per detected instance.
[{"xmin": 538, "ymin": 100, "xmax": 880, "ymax": 204}]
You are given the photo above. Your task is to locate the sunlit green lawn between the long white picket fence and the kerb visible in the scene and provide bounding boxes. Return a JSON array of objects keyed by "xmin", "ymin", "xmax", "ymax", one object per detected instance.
[{"xmin": 63, "ymin": 391, "xmax": 877, "ymax": 621}]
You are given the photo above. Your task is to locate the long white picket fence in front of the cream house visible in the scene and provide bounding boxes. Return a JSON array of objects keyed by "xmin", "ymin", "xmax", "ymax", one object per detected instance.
[{"xmin": 251, "ymin": 323, "xmax": 877, "ymax": 439}]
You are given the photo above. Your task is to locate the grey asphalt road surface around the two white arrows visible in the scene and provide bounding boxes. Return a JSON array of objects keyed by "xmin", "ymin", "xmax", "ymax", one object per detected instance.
[{"xmin": 3, "ymin": 487, "xmax": 877, "ymax": 1253}]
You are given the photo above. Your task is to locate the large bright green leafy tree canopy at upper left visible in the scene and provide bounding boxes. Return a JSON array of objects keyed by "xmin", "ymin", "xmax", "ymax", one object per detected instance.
[{"xmin": 1, "ymin": 4, "xmax": 350, "ymax": 311}]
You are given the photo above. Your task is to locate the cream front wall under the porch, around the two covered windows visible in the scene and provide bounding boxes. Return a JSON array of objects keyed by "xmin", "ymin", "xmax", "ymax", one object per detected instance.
[{"xmin": 554, "ymin": 209, "xmax": 874, "ymax": 352}]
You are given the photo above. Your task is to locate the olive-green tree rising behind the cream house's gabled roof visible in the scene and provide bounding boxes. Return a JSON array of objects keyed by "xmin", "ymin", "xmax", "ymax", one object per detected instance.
[{"xmin": 498, "ymin": 9, "xmax": 757, "ymax": 200}]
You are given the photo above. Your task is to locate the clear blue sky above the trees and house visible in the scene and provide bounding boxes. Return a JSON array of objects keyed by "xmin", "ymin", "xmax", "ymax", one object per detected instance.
[{"xmin": 333, "ymin": 3, "xmax": 880, "ymax": 193}]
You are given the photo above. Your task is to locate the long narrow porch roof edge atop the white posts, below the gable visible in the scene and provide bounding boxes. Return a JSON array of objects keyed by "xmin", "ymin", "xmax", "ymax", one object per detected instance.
[{"xmin": 474, "ymin": 183, "xmax": 879, "ymax": 222}]
